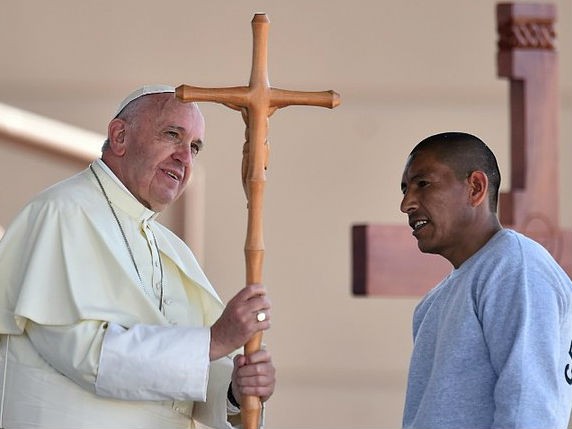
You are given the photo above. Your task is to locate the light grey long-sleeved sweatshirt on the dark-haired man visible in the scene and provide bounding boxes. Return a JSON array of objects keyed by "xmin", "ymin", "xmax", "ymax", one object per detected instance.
[{"xmin": 403, "ymin": 229, "xmax": 572, "ymax": 429}]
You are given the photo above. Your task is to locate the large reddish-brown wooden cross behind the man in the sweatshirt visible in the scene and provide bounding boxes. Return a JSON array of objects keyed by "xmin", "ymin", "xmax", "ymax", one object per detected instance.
[{"xmin": 352, "ymin": 3, "xmax": 572, "ymax": 296}]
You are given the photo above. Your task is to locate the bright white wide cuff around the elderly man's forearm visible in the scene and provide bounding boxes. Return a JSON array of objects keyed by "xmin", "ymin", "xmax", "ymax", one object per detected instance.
[{"xmin": 95, "ymin": 323, "xmax": 210, "ymax": 402}]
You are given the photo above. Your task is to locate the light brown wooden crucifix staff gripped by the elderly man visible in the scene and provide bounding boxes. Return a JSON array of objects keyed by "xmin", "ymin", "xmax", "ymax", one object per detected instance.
[{"xmin": 176, "ymin": 14, "xmax": 340, "ymax": 429}]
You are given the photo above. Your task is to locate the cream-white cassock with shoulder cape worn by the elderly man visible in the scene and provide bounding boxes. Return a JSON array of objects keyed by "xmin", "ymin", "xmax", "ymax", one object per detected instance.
[{"xmin": 0, "ymin": 160, "xmax": 239, "ymax": 429}]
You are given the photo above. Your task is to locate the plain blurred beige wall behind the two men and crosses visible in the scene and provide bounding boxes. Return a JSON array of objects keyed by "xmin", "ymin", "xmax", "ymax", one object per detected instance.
[{"xmin": 0, "ymin": 0, "xmax": 572, "ymax": 429}]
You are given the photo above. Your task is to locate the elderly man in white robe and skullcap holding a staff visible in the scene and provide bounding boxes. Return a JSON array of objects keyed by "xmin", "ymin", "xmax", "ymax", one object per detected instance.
[{"xmin": 0, "ymin": 85, "xmax": 275, "ymax": 429}]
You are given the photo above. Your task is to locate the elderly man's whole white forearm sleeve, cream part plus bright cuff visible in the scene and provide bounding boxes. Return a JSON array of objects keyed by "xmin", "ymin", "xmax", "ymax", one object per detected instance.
[{"xmin": 26, "ymin": 321, "xmax": 210, "ymax": 401}]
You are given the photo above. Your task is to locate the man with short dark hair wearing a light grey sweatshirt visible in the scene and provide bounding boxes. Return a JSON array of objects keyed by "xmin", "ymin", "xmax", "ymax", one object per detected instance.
[{"xmin": 401, "ymin": 132, "xmax": 572, "ymax": 429}]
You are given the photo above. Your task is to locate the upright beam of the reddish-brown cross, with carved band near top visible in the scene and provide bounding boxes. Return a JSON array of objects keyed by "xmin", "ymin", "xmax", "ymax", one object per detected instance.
[{"xmin": 497, "ymin": 3, "xmax": 572, "ymax": 273}]
